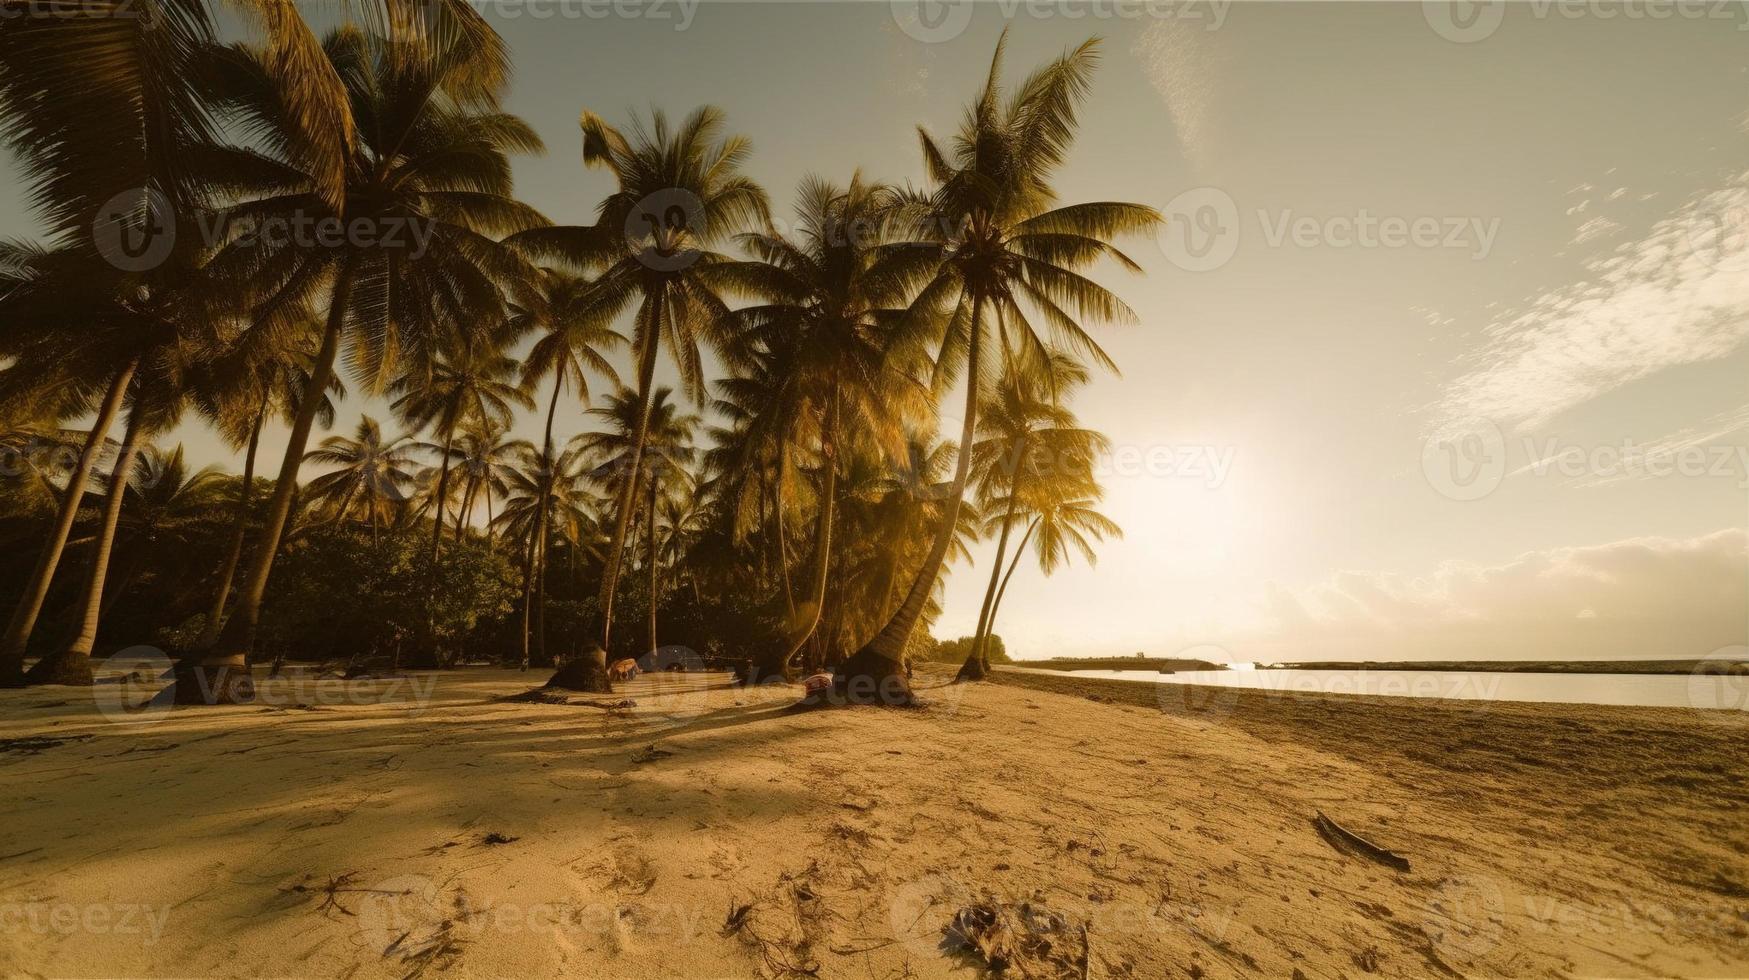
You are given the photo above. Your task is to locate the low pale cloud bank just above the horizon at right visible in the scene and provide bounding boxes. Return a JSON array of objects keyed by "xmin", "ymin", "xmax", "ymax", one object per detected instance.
[{"xmin": 1235, "ymin": 529, "xmax": 1749, "ymax": 660}]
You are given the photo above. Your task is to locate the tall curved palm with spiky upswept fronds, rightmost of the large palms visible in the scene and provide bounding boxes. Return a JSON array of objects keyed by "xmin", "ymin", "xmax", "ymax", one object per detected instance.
[{"xmin": 836, "ymin": 35, "xmax": 1160, "ymax": 704}]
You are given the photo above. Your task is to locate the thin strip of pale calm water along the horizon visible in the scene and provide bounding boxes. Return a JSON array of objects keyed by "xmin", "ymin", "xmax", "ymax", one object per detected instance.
[{"xmin": 1016, "ymin": 667, "xmax": 1749, "ymax": 711}]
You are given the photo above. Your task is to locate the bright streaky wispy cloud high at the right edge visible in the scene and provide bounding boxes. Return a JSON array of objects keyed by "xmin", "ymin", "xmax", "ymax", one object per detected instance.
[{"xmin": 1432, "ymin": 173, "xmax": 1749, "ymax": 432}]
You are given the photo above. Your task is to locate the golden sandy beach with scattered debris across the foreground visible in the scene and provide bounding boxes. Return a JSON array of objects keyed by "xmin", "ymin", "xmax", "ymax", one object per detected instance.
[{"xmin": 0, "ymin": 670, "xmax": 1749, "ymax": 978}]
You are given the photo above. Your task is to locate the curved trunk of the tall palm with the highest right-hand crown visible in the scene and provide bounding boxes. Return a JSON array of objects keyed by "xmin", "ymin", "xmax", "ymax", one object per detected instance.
[{"xmin": 833, "ymin": 296, "xmax": 983, "ymax": 705}]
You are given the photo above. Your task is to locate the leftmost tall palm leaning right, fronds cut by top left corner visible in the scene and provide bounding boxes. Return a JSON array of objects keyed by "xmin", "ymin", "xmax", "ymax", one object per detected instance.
[{"xmin": 0, "ymin": 0, "xmax": 213, "ymax": 686}]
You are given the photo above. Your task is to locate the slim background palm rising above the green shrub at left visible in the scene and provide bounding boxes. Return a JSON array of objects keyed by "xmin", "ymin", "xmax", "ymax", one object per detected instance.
[{"xmin": 390, "ymin": 334, "xmax": 533, "ymax": 565}]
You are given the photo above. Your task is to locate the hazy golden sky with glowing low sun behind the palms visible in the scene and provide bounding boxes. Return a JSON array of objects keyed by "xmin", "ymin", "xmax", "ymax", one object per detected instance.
[{"xmin": 0, "ymin": 0, "xmax": 1749, "ymax": 662}]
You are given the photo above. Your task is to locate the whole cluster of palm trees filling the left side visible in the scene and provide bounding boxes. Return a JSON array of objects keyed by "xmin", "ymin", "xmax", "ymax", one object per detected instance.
[{"xmin": 0, "ymin": 0, "xmax": 1160, "ymax": 704}]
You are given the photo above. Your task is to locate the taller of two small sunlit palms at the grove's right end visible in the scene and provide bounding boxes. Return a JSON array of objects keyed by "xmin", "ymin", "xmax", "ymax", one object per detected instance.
[{"xmin": 960, "ymin": 350, "xmax": 1111, "ymax": 681}]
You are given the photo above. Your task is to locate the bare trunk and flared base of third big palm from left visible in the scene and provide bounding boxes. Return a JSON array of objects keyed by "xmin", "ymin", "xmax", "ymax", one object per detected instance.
[{"xmin": 179, "ymin": 263, "xmax": 353, "ymax": 704}]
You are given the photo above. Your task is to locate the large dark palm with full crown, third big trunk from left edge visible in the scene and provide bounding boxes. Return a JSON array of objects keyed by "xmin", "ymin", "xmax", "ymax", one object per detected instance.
[{"xmin": 175, "ymin": 28, "xmax": 544, "ymax": 704}]
